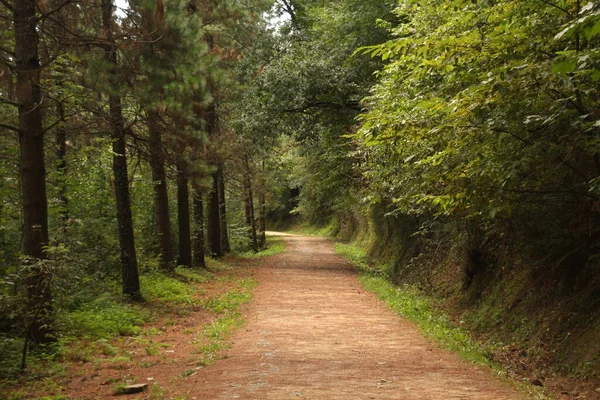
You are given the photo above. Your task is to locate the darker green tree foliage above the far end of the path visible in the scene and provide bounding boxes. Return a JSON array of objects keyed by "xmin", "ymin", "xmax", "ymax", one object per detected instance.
[{"xmin": 232, "ymin": 0, "xmax": 394, "ymax": 222}]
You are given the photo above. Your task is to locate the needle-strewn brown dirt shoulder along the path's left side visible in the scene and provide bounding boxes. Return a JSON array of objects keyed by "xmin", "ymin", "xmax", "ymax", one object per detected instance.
[{"xmin": 56, "ymin": 260, "xmax": 256, "ymax": 400}]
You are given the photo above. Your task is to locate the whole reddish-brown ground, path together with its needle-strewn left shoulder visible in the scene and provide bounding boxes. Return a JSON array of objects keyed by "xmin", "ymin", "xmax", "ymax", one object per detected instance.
[{"xmin": 9, "ymin": 235, "xmax": 544, "ymax": 400}]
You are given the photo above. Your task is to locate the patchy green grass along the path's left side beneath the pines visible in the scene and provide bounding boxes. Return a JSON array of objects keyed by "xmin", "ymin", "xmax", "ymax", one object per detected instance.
[{"xmin": 0, "ymin": 242, "xmax": 276, "ymax": 399}]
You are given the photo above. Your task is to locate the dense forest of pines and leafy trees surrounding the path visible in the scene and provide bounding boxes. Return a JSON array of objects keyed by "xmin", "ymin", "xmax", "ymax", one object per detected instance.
[{"xmin": 0, "ymin": 0, "xmax": 600, "ymax": 394}]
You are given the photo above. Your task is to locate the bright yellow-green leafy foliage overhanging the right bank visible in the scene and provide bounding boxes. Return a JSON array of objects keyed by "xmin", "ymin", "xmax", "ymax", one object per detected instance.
[{"xmin": 354, "ymin": 0, "xmax": 598, "ymax": 256}]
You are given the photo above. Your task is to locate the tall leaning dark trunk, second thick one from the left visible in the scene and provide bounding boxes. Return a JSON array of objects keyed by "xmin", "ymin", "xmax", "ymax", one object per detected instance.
[{"xmin": 102, "ymin": 0, "xmax": 142, "ymax": 300}]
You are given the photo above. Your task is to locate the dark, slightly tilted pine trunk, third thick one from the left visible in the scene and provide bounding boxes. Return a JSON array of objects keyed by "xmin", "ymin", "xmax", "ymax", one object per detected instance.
[{"xmin": 148, "ymin": 111, "xmax": 175, "ymax": 271}]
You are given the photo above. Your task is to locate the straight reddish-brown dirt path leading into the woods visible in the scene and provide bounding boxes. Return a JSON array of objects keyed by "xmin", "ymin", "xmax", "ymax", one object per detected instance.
[{"xmin": 179, "ymin": 236, "xmax": 522, "ymax": 400}]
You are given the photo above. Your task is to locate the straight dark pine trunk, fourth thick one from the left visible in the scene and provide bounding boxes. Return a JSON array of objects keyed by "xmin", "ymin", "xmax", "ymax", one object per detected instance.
[{"xmin": 177, "ymin": 160, "xmax": 192, "ymax": 268}]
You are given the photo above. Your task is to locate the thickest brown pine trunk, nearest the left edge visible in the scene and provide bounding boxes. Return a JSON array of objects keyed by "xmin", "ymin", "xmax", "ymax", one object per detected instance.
[{"xmin": 14, "ymin": 0, "xmax": 56, "ymax": 343}]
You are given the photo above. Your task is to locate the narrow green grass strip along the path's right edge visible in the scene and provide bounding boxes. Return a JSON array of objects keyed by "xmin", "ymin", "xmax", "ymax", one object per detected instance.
[{"xmin": 335, "ymin": 243, "xmax": 548, "ymax": 399}]
